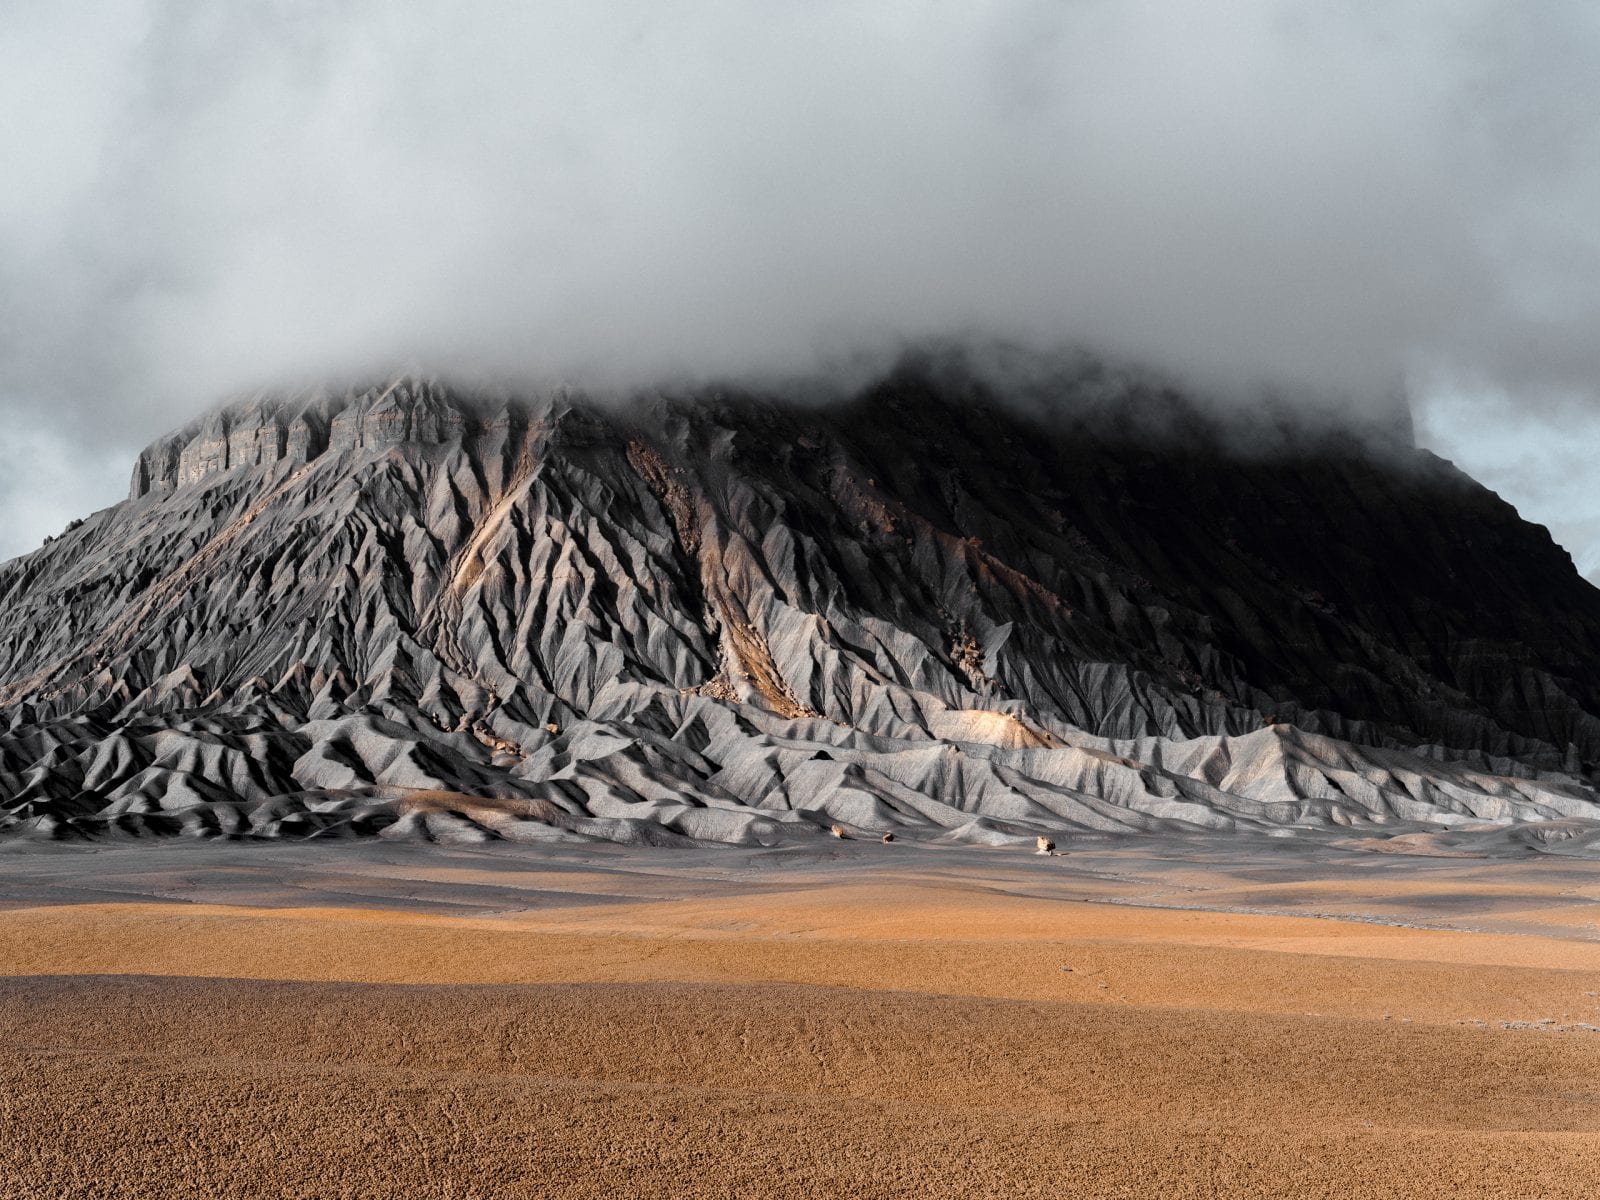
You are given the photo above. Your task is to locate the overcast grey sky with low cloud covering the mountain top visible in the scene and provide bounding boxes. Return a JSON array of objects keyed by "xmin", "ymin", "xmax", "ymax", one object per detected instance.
[{"xmin": 0, "ymin": 0, "xmax": 1600, "ymax": 570}]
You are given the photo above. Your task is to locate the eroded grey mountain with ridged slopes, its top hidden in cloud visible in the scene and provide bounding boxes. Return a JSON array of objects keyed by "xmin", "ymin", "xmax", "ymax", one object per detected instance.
[{"xmin": 0, "ymin": 362, "xmax": 1600, "ymax": 848}]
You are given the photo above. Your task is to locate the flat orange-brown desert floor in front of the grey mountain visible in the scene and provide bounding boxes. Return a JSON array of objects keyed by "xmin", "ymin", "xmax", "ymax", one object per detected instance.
[{"xmin": 0, "ymin": 838, "xmax": 1600, "ymax": 1198}]
